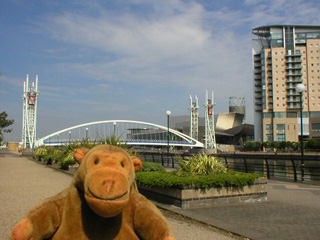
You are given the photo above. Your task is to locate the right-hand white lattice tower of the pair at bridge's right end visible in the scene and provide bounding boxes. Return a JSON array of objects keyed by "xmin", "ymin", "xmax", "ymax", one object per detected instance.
[{"xmin": 204, "ymin": 91, "xmax": 217, "ymax": 151}]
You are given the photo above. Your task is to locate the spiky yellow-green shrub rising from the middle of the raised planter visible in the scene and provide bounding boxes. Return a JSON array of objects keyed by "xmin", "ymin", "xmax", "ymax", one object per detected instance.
[{"xmin": 177, "ymin": 154, "xmax": 227, "ymax": 176}]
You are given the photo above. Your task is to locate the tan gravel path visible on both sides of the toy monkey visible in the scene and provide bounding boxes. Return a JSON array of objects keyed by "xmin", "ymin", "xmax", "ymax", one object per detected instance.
[{"xmin": 0, "ymin": 151, "xmax": 235, "ymax": 240}]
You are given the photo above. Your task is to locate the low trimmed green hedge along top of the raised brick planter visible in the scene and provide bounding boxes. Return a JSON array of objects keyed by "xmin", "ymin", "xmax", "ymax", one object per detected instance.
[{"xmin": 136, "ymin": 171, "xmax": 265, "ymax": 188}]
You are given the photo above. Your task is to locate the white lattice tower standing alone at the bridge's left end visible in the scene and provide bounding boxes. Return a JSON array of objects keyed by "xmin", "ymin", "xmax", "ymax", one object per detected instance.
[{"xmin": 22, "ymin": 74, "xmax": 40, "ymax": 149}]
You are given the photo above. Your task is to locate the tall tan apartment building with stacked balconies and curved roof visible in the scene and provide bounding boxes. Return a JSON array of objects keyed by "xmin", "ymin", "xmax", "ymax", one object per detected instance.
[{"xmin": 252, "ymin": 25, "xmax": 320, "ymax": 142}]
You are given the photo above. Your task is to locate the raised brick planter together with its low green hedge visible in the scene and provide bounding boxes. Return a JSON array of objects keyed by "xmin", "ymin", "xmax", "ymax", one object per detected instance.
[{"xmin": 136, "ymin": 172, "xmax": 267, "ymax": 208}]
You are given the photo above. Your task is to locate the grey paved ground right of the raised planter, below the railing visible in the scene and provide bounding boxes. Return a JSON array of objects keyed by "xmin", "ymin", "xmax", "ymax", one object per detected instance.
[{"xmin": 159, "ymin": 175, "xmax": 320, "ymax": 240}]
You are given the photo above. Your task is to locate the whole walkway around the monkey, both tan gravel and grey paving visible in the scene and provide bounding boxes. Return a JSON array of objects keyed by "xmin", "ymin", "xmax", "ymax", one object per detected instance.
[{"xmin": 0, "ymin": 152, "xmax": 320, "ymax": 240}]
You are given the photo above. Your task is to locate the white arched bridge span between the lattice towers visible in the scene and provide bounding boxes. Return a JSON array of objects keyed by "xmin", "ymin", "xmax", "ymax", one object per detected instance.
[{"xmin": 37, "ymin": 120, "xmax": 204, "ymax": 148}]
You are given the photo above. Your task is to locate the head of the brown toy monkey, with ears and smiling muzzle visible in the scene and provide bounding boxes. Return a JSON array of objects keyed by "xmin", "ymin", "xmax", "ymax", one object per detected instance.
[{"xmin": 74, "ymin": 145, "xmax": 142, "ymax": 217}]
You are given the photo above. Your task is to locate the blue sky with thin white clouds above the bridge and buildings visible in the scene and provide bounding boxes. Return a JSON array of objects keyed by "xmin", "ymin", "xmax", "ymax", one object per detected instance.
[{"xmin": 0, "ymin": 0, "xmax": 320, "ymax": 141}]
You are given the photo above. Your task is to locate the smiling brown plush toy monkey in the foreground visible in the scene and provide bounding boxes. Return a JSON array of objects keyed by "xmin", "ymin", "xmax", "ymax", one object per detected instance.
[{"xmin": 11, "ymin": 145, "xmax": 174, "ymax": 240}]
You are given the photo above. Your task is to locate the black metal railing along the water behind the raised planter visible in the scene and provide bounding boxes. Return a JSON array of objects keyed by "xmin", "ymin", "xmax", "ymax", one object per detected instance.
[{"xmin": 140, "ymin": 152, "xmax": 320, "ymax": 181}]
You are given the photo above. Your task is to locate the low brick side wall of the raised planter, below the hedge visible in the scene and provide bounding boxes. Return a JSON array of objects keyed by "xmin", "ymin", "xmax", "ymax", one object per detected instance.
[{"xmin": 138, "ymin": 177, "xmax": 267, "ymax": 208}]
